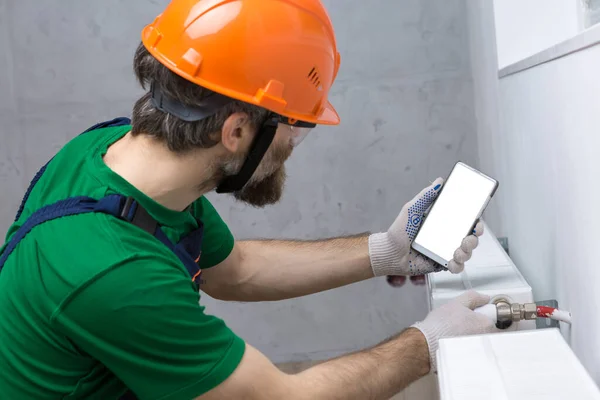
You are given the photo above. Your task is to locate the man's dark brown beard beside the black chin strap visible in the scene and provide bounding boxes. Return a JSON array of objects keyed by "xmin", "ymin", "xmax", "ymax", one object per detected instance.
[{"xmin": 233, "ymin": 164, "xmax": 286, "ymax": 207}]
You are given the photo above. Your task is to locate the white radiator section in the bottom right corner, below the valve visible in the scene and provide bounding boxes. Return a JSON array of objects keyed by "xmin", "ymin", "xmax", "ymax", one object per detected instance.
[{"xmin": 438, "ymin": 328, "xmax": 600, "ymax": 400}]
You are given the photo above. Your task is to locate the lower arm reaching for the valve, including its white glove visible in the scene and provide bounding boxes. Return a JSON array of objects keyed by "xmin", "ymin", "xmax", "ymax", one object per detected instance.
[{"xmin": 199, "ymin": 291, "xmax": 497, "ymax": 400}]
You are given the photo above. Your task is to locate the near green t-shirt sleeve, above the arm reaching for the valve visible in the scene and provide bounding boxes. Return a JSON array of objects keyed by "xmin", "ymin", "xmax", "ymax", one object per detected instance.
[{"xmin": 52, "ymin": 258, "xmax": 245, "ymax": 400}]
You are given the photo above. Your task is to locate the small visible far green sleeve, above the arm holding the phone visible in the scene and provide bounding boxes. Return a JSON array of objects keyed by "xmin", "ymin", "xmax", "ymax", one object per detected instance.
[{"xmin": 194, "ymin": 196, "xmax": 234, "ymax": 269}]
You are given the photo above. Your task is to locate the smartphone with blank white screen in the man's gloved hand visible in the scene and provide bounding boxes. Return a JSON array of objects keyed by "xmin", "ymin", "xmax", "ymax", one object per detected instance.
[{"xmin": 412, "ymin": 161, "xmax": 498, "ymax": 267}]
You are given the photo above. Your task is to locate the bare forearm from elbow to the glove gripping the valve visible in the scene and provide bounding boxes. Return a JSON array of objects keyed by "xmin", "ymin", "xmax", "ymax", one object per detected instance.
[{"xmin": 296, "ymin": 328, "xmax": 430, "ymax": 400}]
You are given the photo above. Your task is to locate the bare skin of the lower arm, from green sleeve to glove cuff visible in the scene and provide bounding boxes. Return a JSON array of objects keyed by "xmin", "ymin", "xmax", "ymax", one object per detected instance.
[{"xmin": 198, "ymin": 328, "xmax": 430, "ymax": 400}]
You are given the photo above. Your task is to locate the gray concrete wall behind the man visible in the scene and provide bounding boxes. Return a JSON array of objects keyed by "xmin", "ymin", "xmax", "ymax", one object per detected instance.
[{"xmin": 0, "ymin": 0, "xmax": 477, "ymax": 361}]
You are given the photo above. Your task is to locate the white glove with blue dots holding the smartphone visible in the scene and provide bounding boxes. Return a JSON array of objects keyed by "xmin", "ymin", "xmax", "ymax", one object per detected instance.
[{"xmin": 369, "ymin": 178, "xmax": 483, "ymax": 276}]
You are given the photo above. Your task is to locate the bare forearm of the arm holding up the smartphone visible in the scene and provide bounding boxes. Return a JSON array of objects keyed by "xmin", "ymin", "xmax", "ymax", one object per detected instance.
[{"xmin": 232, "ymin": 235, "xmax": 373, "ymax": 301}]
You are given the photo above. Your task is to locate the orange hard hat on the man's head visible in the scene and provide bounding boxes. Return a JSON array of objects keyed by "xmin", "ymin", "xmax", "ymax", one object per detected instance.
[{"xmin": 142, "ymin": 0, "xmax": 340, "ymax": 125}]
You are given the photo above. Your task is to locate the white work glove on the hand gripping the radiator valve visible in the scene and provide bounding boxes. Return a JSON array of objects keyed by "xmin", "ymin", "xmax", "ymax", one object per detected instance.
[{"xmin": 412, "ymin": 290, "xmax": 499, "ymax": 372}]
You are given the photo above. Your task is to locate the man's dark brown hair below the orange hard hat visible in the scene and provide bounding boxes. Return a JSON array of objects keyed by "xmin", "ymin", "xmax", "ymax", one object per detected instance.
[{"xmin": 131, "ymin": 43, "xmax": 269, "ymax": 153}]
